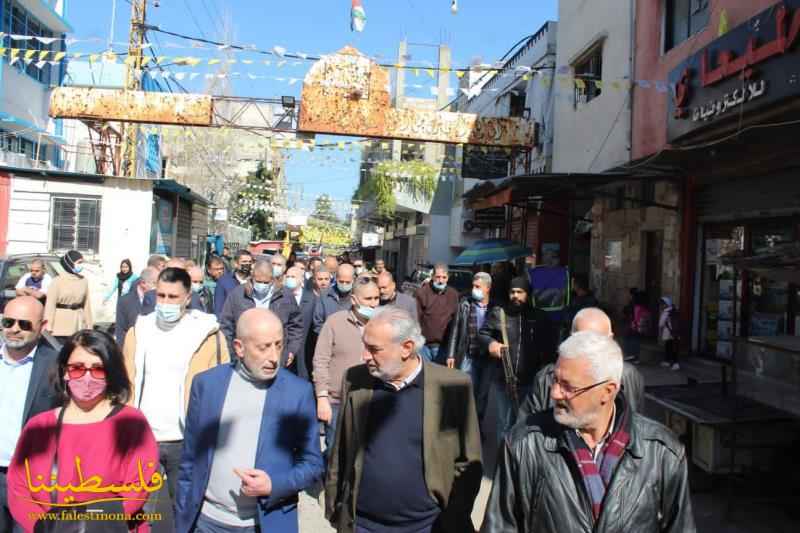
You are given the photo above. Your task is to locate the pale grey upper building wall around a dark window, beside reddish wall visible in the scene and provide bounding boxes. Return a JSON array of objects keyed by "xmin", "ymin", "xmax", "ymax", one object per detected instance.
[{"xmin": 553, "ymin": 0, "xmax": 632, "ymax": 172}]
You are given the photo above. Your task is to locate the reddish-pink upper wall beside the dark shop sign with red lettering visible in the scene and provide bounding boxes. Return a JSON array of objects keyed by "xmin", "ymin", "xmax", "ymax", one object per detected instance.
[{"xmin": 632, "ymin": 0, "xmax": 780, "ymax": 159}]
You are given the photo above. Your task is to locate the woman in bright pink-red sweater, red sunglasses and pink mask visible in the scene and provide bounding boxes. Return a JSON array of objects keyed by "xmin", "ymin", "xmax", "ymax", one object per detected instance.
[{"xmin": 8, "ymin": 330, "xmax": 163, "ymax": 532}]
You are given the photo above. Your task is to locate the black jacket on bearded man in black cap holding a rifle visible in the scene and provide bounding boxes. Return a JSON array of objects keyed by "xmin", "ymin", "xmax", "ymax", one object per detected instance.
[{"xmin": 479, "ymin": 306, "xmax": 558, "ymax": 387}]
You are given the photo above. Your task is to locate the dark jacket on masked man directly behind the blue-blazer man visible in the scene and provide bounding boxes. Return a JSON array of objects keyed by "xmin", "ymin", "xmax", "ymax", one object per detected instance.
[{"xmin": 219, "ymin": 281, "xmax": 303, "ymax": 363}]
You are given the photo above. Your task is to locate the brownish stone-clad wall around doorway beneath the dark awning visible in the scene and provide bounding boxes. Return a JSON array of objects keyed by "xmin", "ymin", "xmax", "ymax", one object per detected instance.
[{"xmin": 590, "ymin": 182, "xmax": 681, "ymax": 313}]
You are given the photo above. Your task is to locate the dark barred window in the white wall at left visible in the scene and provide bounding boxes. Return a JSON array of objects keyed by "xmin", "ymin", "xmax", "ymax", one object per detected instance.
[{"xmin": 52, "ymin": 197, "xmax": 100, "ymax": 253}]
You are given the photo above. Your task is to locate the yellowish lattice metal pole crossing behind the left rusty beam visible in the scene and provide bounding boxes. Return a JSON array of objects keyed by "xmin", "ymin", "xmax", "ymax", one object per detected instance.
[{"xmin": 122, "ymin": 0, "xmax": 147, "ymax": 178}]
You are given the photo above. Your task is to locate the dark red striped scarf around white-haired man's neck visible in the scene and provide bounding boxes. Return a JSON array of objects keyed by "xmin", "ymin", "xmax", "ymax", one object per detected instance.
[{"xmin": 566, "ymin": 394, "xmax": 631, "ymax": 521}]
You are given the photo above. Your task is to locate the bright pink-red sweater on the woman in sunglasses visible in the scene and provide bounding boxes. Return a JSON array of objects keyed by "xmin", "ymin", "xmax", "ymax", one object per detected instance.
[{"xmin": 8, "ymin": 406, "xmax": 158, "ymax": 532}]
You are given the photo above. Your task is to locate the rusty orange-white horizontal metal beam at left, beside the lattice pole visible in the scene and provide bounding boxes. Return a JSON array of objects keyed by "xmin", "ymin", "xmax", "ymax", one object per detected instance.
[{"xmin": 49, "ymin": 87, "xmax": 213, "ymax": 126}]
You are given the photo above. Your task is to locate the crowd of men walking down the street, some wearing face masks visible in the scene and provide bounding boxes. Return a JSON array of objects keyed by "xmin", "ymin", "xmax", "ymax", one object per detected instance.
[{"xmin": 0, "ymin": 250, "xmax": 694, "ymax": 533}]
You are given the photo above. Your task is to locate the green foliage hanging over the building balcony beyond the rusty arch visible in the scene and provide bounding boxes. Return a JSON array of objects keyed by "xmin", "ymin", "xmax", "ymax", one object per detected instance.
[{"xmin": 353, "ymin": 161, "xmax": 439, "ymax": 216}]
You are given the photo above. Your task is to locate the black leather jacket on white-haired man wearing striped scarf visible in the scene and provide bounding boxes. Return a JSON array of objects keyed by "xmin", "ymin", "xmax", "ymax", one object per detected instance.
[{"xmin": 481, "ymin": 404, "xmax": 696, "ymax": 533}]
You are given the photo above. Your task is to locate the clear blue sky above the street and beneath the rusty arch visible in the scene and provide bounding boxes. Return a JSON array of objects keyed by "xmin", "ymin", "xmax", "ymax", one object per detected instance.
[{"xmin": 67, "ymin": 0, "xmax": 558, "ymax": 215}]
